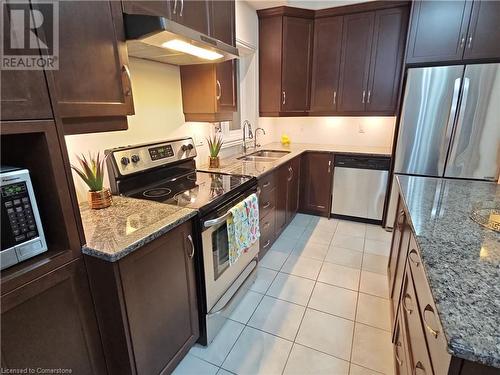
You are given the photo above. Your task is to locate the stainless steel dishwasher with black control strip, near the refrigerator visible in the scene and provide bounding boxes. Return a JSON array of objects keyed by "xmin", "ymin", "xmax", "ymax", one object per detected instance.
[{"xmin": 332, "ymin": 155, "xmax": 390, "ymax": 223}]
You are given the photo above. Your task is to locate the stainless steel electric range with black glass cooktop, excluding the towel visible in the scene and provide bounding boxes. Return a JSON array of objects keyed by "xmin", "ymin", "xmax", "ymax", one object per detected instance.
[{"xmin": 106, "ymin": 138, "xmax": 258, "ymax": 345}]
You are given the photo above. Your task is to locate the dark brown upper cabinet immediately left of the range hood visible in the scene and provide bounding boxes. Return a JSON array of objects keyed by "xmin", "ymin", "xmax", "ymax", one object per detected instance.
[{"xmin": 35, "ymin": 1, "xmax": 134, "ymax": 134}]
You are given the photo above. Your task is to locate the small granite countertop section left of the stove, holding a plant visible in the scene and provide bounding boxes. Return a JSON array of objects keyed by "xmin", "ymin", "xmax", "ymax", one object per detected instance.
[{"xmin": 80, "ymin": 196, "xmax": 197, "ymax": 262}]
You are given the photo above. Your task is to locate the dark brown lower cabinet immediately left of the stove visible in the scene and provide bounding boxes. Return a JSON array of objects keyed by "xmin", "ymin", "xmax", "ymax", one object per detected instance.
[{"xmin": 85, "ymin": 222, "xmax": 199, "ymax": 374}]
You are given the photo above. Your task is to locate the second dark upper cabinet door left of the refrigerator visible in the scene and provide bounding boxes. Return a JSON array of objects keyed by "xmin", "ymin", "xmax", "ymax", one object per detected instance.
[{"xmin": 337, "ymin": 12, "xmax": 375, "ymax": 113}]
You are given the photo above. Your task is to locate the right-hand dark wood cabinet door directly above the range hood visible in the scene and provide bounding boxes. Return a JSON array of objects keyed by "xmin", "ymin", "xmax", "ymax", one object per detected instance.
[{"xmin": 210, "ymin": 0, "xmax": 236, "ymax": 46}]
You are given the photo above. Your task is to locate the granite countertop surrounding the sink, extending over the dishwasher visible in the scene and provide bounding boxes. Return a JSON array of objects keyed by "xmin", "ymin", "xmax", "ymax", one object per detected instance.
[{"xmin": 197, "ymin": 142, "xmax": 392, "ymax": 177}]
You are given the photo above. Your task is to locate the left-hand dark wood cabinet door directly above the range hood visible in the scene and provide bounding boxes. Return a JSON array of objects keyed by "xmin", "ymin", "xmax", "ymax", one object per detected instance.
[{"xmin": 172, "ymin": 0, "xmax": 209, "ymax": 35}]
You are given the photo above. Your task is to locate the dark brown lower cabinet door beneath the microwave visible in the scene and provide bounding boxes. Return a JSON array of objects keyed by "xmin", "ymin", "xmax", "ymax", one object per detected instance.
[{"xmin": 1, "ymin": 258, "xmax": 106, "ymax": 374}]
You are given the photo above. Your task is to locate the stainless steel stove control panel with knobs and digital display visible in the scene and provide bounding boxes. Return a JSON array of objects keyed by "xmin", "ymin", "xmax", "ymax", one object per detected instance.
[{"xmin": 106, "ymin": 138, "xmax": 196, "ymax": 176}]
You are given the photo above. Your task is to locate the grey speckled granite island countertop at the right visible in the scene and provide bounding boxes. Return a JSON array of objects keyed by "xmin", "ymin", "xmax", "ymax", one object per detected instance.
[{"xmin": 398, "ymin": 176, "xmax": 500, "ymax": 368}]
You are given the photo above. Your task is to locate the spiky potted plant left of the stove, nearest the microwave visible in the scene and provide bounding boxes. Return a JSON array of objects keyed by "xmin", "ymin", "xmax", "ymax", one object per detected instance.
[{"xmin": 71, "ymin": 152, "xmax": 112, "ymax": 209}]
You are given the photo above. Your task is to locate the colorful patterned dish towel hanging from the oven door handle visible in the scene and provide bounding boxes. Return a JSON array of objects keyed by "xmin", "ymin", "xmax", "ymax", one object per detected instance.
[{"xmin": 227, "ymin": 194, "xmax": 260, "ymax": 266}]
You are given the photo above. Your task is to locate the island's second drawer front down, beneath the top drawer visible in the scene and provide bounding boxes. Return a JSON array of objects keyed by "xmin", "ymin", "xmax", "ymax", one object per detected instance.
[{"xmin": 400, "ymin": 266, "xmax": 433, "ymax": 374}]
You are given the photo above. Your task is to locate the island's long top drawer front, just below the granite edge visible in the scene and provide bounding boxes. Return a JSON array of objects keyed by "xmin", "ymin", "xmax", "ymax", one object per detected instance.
[{"xmin": 408, "ymin": 237, "xmax": 451, "ymax": 374}]
